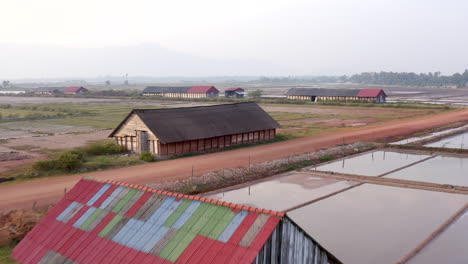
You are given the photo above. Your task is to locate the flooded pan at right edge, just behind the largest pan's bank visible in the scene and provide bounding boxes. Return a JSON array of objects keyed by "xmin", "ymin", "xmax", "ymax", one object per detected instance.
[{"xmin": 385, "ymin": 156, "xmax": 468, "ymax": 186}]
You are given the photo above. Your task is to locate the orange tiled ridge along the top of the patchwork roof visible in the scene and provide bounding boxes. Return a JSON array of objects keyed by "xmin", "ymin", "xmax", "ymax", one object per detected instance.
[{"xmin": 89, "ymin": 178, "xmax": 285, "ymax": 217}]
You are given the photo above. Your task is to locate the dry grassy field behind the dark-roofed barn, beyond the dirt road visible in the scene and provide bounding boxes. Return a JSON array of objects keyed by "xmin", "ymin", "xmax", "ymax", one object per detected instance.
[{"xmin": 0, "ymin": 96, "xmax": 454, "ymax": 180}]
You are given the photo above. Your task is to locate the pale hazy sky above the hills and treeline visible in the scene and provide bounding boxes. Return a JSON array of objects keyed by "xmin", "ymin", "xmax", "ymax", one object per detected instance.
[{"xmin": 0, "ymin": 0, "xmax": 468, "ymax": 75}]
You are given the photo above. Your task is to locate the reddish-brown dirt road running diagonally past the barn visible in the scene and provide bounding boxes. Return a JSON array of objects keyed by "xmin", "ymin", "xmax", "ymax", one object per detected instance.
[{"xmin": 0, "ymin": 109, "xmax": 468, "ymax": 212}]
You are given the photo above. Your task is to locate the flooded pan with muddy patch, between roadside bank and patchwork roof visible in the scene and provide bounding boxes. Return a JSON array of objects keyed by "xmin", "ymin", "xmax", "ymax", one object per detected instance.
[{"xmin": 208, "ymin": 172, "xmax": 353, "ymax": 211}]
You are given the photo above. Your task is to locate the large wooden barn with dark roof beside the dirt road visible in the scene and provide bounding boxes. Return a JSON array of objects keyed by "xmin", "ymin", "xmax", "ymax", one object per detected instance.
[{"xmin": 109, "ymin": 102, "xmax": 280, "ymax": 156}]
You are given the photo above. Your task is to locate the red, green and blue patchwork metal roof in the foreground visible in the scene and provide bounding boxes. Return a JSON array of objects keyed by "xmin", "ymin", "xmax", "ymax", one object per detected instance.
[{"xmin": 13, "ymin": 180, "xmax": 284, "ymax": 263}]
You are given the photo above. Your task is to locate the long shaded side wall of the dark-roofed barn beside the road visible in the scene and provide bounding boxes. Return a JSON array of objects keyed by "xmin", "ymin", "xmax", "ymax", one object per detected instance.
[{"xmin": 159, "ymin": 129, "xmax": 276, "ymax": 156}]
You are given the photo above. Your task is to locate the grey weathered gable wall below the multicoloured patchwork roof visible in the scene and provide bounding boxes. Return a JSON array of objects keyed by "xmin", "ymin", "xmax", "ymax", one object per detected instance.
[{"xmin": 252, "ymin": 217, "xmax": 334, "ymax": 264}]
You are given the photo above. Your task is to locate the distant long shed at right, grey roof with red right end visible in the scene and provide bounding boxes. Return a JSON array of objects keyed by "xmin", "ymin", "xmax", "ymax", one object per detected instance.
[{"xmin": 287, "ymin": 88, "xmax": 387, "ymax": 103}]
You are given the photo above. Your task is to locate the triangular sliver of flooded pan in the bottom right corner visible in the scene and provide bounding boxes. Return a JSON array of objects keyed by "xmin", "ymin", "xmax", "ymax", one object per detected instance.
[{"xmin": 408, "ymin": 209, "xmax": 468, "ymax": 264}]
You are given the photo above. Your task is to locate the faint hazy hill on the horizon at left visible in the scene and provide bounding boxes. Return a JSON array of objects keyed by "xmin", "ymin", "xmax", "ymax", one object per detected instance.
[{"xmin": 0, "ymin": 44, "xmax": 287, "ymax": 79}]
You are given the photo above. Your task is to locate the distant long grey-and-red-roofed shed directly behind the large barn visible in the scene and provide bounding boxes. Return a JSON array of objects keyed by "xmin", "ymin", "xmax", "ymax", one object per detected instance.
[{"xmin": 142, "ymin": 85, "xmax": 219, "ymax": 98}]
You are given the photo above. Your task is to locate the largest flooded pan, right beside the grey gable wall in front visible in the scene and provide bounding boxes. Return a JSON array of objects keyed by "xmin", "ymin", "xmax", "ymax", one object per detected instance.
[{"xmin": 288, "ymin": 184, "xmax": 468, "ymax": 264}]
